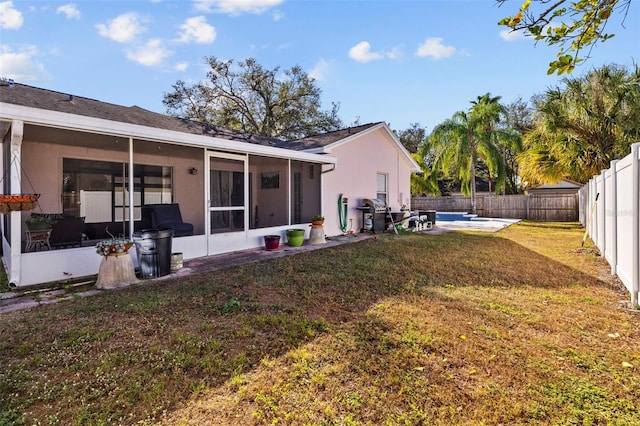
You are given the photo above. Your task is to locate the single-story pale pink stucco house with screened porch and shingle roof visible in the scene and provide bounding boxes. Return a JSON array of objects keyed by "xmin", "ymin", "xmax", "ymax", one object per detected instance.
[{"xmin": 0, "ymin": 81, "xmax": 417, "ymax": 286}]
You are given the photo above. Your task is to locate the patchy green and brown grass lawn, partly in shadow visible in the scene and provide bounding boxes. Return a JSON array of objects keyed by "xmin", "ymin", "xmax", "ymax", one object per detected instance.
[{"xmin": 0, "ymin": 222, "xmax": 640, "ymax": 425}]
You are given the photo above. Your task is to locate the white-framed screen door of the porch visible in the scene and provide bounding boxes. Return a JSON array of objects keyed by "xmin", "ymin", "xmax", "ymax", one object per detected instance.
[{"xmin": 209, "ymin": 153, "xmax": 248, "ymax": 234}]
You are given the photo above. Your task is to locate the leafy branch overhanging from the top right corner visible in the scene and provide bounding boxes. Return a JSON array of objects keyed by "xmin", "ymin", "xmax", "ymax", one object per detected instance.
[{"xmin": 496, "ymin": 0, "xmax": 631, "ymax": 75}]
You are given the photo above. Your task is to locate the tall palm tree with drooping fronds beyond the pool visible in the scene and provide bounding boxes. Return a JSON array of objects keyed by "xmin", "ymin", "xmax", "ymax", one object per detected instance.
[{"xmin": 428, "ymin": 93, "xmax": 515, "ymax": 214}]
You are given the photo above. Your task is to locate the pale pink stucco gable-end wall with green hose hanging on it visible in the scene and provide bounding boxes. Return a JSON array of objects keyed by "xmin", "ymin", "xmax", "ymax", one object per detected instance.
[{"xmin": 322, "ymin": 129, "xmax": 411, "ymax": 236}]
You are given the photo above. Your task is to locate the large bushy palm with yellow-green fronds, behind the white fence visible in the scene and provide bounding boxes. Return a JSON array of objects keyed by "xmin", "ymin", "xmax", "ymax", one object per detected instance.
[{"xmin": 519, "ymin": 65, "xmax": 640, "ymax": 185}]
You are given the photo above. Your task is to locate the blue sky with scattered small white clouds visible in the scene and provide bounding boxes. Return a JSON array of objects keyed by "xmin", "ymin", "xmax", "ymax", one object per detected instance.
[{"xmin": 0, "ymin": 0, "xmax": 640, "ymax": 132}]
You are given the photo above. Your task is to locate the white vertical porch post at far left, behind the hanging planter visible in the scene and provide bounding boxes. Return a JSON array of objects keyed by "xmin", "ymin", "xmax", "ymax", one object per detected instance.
[{"xmin": 8, "ymin": 120, "xmax": 24, "ymax": 286}]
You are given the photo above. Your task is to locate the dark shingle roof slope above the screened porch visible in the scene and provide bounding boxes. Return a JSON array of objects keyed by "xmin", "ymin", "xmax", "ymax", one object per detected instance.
[{"xmin": 0, "ymin": 81, "xmax": 289, "ymax": 148}]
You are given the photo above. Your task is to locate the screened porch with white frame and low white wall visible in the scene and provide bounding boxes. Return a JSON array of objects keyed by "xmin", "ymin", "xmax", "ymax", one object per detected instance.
[{"xmin": 0, "ymin": 86, "xmax": 336, "ymax": 286}]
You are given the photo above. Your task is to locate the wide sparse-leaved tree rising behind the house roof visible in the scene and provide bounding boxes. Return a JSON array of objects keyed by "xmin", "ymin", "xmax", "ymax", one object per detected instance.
[{"xmin": 162, "ymin": 56, "xmax": 342, "ymax": 140}]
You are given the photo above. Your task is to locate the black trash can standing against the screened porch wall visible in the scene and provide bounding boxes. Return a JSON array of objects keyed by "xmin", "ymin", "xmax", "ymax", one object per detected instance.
[{"xmin": 133, "ymin": 228, "xmax": 173, "ymax": 278}]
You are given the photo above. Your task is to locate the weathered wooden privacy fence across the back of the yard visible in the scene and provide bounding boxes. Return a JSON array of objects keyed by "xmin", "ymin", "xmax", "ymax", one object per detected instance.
[{"xmin": 411, "ymin": 194, "xmax": 579, "ymax": 222}]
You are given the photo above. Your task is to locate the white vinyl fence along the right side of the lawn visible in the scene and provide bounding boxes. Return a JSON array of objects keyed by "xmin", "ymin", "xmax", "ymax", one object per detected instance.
[{"xmin": 580, "ymin": 143, "xmax": 640, "ymax": 306}]
